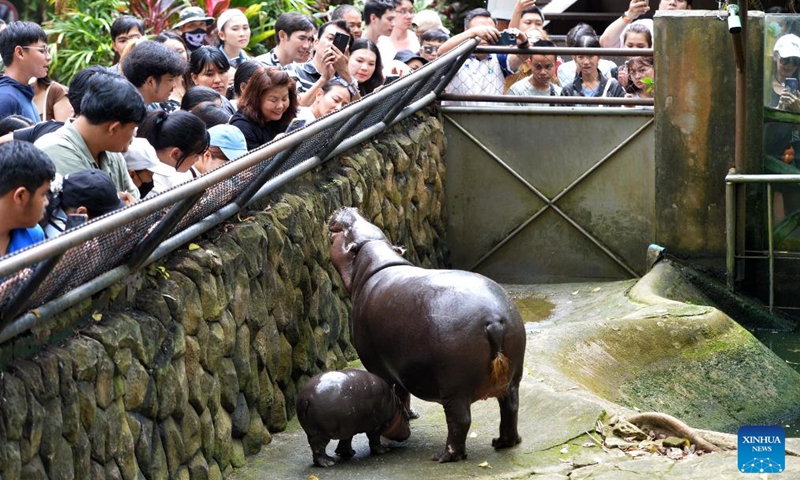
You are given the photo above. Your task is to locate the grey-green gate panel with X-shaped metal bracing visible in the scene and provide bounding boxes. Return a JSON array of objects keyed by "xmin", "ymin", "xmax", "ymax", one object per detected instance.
[{"xmin": 445, "ymin": 108, "xmax": 655, "ymax": 283}]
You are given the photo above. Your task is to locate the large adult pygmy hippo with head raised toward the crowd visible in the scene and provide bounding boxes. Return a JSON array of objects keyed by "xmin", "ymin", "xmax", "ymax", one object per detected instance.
[{"xmin": 328, "ymin": 208, "xmax": 525, "ymax": 462}]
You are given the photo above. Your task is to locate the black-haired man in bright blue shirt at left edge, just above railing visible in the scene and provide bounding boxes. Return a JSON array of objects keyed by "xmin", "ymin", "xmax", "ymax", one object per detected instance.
[{"xmin": 0, "ymin": 140, "xmax": 56, "ymax": 257}]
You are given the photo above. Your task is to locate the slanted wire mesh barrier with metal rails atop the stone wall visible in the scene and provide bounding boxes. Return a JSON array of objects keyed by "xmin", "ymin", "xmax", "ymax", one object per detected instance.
[{"xmin": 0, "ymin": 41, "xmax": 477, "ymax": 343}]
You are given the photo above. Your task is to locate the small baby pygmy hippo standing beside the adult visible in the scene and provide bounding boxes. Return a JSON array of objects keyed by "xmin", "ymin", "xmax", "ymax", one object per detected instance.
[{"xmin": 295, "ymin": 369, "xmax": 411, "ymax": 467}]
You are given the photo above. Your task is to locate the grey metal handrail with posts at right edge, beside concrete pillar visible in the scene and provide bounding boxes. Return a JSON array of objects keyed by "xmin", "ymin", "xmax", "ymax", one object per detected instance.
[{"xmin": 725, "ymin": 168, "xmax": 800, "ymax": 313}]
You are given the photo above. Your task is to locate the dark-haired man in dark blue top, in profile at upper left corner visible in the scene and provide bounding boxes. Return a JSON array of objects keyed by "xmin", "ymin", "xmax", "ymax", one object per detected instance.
[{"xmin": 0, "ymin": 22, "xmax": 50, "ymax": 123}]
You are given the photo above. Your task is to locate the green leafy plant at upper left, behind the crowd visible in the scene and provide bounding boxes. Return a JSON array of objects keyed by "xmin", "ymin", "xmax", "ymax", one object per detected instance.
[{"xmin": 43, "ymin": 0, "xmax": 125, "ymax": 84}]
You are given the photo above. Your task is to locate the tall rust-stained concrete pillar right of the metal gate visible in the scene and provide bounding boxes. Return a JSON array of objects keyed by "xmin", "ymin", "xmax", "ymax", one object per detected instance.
[{"xmin": 655, "ymin": 10, "xmax": 764, "ymax": 272}]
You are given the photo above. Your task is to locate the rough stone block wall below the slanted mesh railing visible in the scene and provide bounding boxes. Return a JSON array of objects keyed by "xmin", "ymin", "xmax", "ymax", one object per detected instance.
[{"xmin": 0, "ymin": 111, "xmax": 447, "ymax": 480}]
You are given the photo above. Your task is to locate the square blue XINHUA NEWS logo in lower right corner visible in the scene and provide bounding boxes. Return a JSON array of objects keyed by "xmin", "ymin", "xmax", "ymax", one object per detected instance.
[{"xmin": 739, "ymin": 425, "xmax": 786, "ymax": 473}]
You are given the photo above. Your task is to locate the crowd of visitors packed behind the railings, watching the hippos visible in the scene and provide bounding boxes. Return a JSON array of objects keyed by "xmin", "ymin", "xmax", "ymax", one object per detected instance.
[{"xmin": 0, "ymin": 0, "xmax": 676, "ymax": 256}]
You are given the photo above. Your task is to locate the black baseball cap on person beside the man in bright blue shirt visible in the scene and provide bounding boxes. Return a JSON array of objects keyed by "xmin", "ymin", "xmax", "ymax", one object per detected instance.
[{"xmin": 61, "ymin": 168, "xmax": 125, "ymax": 217}]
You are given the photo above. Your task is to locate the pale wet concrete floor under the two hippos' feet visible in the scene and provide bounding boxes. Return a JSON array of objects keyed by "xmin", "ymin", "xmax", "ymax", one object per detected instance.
[{"xmin": 229, "ymin": 281, "xmax": 800, "ymax": 480}]
